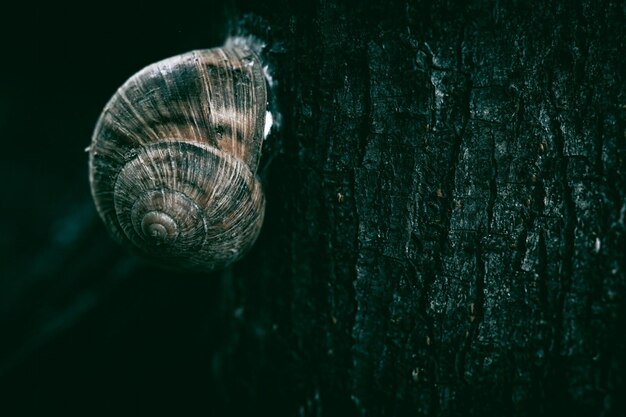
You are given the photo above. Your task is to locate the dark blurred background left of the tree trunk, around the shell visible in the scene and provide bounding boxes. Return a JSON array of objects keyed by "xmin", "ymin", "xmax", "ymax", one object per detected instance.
[{"xmin": 0, "ymin": 2, "xmax": 266, "ymax": 417}]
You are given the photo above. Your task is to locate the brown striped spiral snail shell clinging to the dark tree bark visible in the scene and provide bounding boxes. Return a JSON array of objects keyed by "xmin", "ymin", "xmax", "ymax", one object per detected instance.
[{"xmin": 89, "ymin": 45, "xmax": 267, "ymax": 271}]
